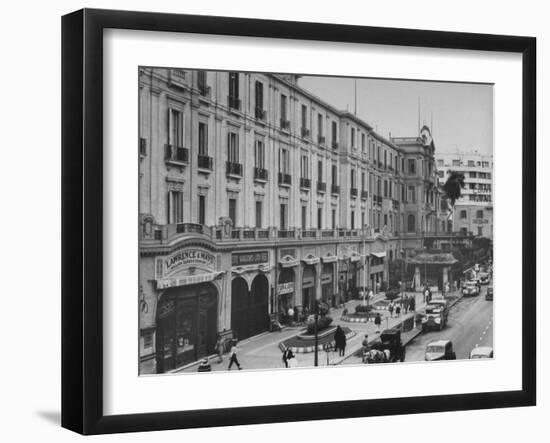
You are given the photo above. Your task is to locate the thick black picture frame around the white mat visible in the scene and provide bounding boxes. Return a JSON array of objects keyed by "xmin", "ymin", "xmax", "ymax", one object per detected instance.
[{"xmin": 62, "ymin": 9, "xmax": 536, "ymax": 434}]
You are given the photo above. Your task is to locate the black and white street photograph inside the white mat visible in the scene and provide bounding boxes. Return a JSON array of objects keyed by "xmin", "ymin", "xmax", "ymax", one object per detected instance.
[{"xmin": 135, "ymin": 66, "xmax": 499, "ymax": 376}]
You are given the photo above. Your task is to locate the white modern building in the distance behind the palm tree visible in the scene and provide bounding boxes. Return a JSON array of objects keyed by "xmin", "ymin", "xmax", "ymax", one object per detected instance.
[{"xmin": 437, "ymin": 152, "xmax": 493, "ymax": 239}]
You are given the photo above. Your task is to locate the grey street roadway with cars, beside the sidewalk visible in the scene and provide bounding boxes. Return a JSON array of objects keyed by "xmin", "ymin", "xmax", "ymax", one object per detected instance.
[{"xmin": 405, "ymin": 285, "xmax": 493, "ymax": 361}]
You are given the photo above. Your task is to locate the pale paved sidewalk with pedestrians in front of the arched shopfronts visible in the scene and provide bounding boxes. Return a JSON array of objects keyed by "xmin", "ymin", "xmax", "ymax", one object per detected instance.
[{"xmin": 174, "ymin": 293, "xmax": 464, "ymax": 373}]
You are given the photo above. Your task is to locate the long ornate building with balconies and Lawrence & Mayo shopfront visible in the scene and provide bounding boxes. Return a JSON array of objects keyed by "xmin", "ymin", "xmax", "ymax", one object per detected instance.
[{"xmin": 139, "ymin": 68, "xmax": 439, "ymax": 373}]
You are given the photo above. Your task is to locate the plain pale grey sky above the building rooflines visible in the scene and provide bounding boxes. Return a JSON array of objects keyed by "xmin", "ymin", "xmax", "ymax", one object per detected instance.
[{"xmin": 298, "ymin": 76, "xmax": 493, "ymax": 155}]
